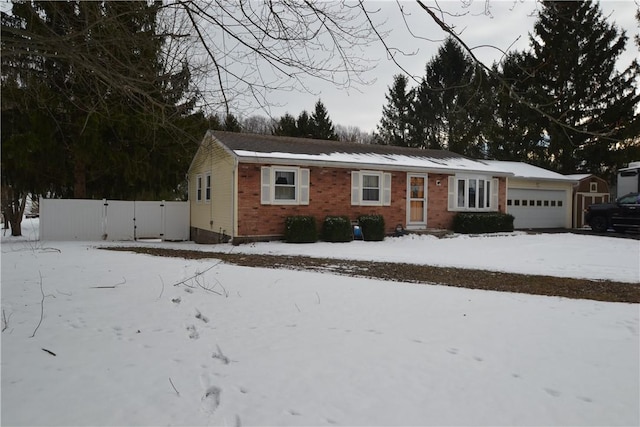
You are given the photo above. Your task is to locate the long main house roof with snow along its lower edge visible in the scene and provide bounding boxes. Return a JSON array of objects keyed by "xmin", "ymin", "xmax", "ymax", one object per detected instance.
[{"xmin": 209, "ymin": 131, "xmax": 511, "ymax": 176}]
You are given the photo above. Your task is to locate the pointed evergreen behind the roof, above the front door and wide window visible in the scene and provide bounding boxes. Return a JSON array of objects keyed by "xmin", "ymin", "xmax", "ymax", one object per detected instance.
[{"xmin": 412, "ymin": 37, "xmax": 486, "ymax": 156}]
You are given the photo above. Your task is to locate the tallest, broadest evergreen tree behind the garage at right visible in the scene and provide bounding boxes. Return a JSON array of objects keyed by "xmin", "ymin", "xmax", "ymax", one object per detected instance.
[{"xmin": 525, "ymin": 0, "xmax": 640, "ymax": 175}]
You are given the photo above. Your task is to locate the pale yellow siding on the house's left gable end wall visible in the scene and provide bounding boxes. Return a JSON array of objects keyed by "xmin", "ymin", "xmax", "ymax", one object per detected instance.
[{"xmin": 189, "ymin": 135, "xmax": 235, "ymax": 235}]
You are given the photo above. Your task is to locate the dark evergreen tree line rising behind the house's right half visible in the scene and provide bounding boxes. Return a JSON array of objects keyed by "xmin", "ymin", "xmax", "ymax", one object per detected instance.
[{"xmin": 377, "ymin": 1, "xmax": 640, "ymax": 177}]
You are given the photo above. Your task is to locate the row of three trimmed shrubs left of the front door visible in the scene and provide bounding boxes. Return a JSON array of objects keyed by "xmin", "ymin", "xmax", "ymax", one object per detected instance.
[{"xmin": 284, "ymin": 215, "xmax": 385, "ymax": 243}]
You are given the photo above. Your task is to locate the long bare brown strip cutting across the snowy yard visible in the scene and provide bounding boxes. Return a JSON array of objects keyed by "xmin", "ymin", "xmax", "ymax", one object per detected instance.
[{"xmin": 101, "ymin": 247, "xmax": 640, "ymax": 303}]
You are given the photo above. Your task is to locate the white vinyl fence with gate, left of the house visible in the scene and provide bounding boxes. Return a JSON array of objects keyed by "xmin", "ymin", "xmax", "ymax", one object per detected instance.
[{"xmin": 40, "ymin": 199, "xmax": 189, "ymax": 241}]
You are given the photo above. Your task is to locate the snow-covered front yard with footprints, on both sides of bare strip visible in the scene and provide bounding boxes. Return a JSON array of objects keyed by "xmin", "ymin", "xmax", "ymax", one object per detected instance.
[{"xmin": 1, "ymin": 220, "xmax": 640, "ymax": 425}]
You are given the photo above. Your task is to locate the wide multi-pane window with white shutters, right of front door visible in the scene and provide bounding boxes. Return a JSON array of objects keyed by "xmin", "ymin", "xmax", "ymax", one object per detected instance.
[{"xmin": 449, "ymin": 175, "xmax": 498, "ymax": 211}]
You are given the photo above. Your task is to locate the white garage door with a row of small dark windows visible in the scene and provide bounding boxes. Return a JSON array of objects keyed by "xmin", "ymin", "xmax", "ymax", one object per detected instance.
[{"xmin": 507, "ymin": 189, "xmax": 569, "ymax": 229}]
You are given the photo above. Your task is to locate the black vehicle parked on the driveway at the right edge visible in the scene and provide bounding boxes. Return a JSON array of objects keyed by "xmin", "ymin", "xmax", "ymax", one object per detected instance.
[{"xmin": 585, "ymin": 193, "xmax": 640, "ymax": 233}]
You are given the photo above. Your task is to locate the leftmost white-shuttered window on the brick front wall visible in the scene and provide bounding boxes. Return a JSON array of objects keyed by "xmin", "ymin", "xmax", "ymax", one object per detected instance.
[{"xmin": 260, "ymin": 166, "xmax": 309, "ymax": 205}]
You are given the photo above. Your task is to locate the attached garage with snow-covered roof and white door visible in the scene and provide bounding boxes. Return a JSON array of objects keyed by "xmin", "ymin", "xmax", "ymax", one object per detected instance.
[{"xmin": 487, "ymin": 161, "xmax": 578, "ymax": 229}]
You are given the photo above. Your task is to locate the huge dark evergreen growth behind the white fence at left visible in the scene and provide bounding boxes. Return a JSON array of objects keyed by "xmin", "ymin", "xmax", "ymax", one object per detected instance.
[{"xmin": 2, "ymin": 1, "xmax": 206, "ymax": 212}]
